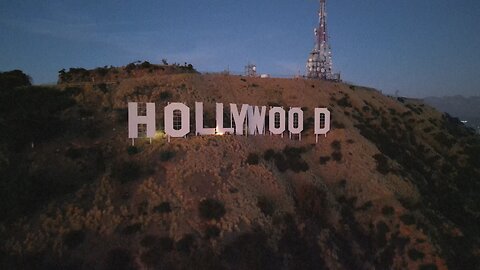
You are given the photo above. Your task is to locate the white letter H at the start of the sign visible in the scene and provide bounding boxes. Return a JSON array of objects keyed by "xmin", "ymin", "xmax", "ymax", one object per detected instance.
[{"xmin": 128, "ymin": 102, "xmax": 156, "ymax": 139}]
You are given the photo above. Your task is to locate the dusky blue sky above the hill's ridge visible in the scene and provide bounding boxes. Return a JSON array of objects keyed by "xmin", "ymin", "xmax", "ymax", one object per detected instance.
[{"xmin": 0, "ymin": 0, "xmax": 480, "ymax": 97}]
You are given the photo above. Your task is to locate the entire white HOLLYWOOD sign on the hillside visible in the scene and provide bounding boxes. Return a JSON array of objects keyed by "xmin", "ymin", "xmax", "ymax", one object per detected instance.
[{"xmin": 128, "ymin": 102, "xmax": 330, "ymax": 144}]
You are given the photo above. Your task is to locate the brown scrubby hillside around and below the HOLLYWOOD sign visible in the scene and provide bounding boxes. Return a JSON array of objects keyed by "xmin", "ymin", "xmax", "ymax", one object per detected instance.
[{"xmin": 0, "ymin": 65, "xmax": 480, "ymax": 270}]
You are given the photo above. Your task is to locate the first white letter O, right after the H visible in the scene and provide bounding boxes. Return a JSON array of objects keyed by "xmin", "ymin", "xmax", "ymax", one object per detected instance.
[{"xmin": 164, "ymin": 103, "xmax": 190, "ymax": 138}]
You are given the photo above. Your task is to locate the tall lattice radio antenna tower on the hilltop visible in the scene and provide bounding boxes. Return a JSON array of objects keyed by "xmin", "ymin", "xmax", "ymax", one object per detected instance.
[{"xmin": 307, "ymin": 0, "xmax": 340, "ymax": 81}]
